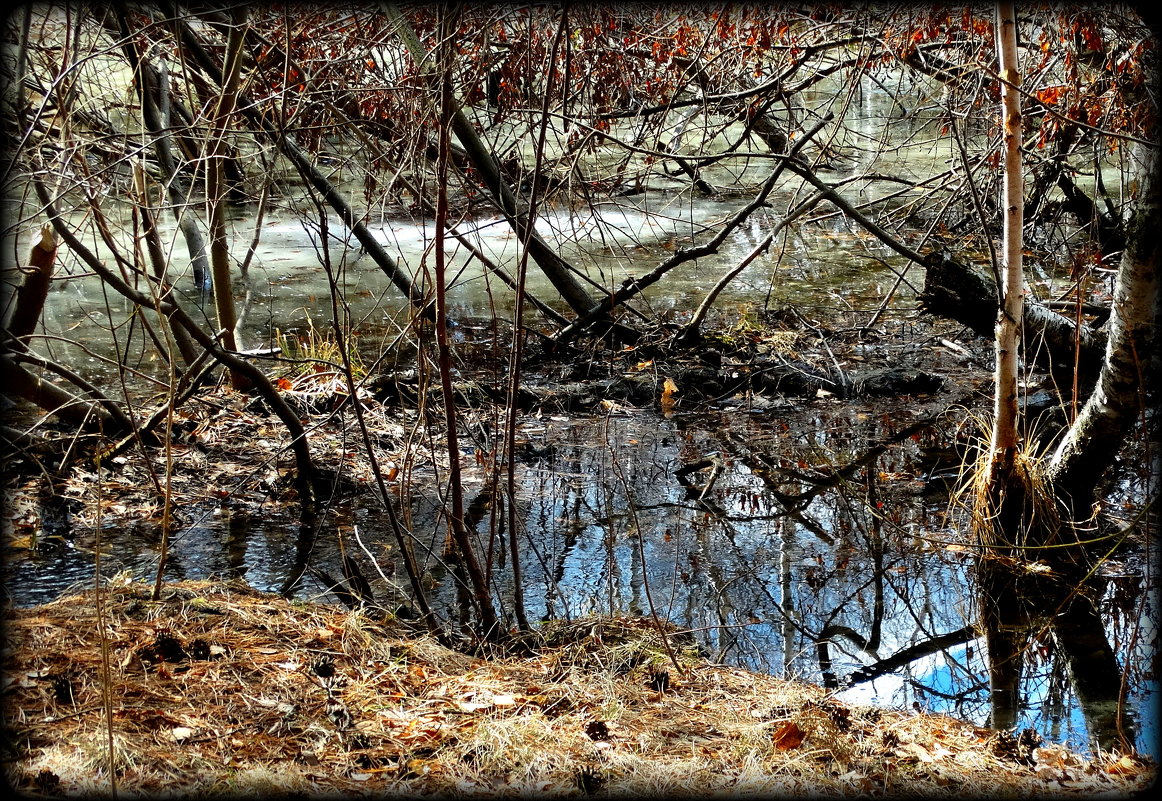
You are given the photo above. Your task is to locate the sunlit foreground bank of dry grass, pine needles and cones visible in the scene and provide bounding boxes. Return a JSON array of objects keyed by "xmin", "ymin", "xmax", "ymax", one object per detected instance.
[{"xmin": 3, "ymin": 582, "xmax": 1154, "ymax": 798}]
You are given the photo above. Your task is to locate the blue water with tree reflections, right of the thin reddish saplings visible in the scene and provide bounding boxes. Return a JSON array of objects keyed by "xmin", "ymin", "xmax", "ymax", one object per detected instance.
[{"xmin": 474, "ymin": 405, "xmax": 1152, "ymax": 748}]
